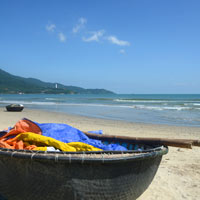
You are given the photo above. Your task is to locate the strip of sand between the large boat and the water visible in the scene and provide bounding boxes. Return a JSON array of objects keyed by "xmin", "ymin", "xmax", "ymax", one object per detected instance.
[{"xmin": 0, "ymin": 107, "xmax": 200, "ymax": 139}]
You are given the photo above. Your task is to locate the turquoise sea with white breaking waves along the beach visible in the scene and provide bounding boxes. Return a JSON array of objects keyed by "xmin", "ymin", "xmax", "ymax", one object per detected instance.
[{"xmin": 0, "ymin": 94, "xmax": 200, "ymax": 126}]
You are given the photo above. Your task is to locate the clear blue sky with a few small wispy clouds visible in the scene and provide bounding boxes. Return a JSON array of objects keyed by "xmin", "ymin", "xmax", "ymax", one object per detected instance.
[{"xmin": 0, "ymin": 0, "xmax": 200, "ymax": 93}]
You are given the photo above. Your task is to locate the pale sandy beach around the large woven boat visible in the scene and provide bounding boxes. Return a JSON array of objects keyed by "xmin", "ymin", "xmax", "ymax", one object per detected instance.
[{"xmin": 0, "ymin": 108, "xmax": 200, "ymax": 200}]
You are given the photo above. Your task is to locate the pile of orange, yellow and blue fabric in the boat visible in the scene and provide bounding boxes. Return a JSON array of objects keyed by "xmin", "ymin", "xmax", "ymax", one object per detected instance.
[{"xmin": 0, "ymin": 118, "xmax": 127, "ymax": 152}]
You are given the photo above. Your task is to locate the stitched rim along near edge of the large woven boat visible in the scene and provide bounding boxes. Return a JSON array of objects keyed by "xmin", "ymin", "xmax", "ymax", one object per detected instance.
[{"xmin": 0, "ymin": 146, "xmax": 168, "ymax": 163}]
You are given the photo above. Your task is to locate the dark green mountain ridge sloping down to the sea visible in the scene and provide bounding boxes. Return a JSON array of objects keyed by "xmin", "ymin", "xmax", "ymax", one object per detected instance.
[{"xmin": 0, "ymin": 69, "xmax": 114, "ymax": 94}]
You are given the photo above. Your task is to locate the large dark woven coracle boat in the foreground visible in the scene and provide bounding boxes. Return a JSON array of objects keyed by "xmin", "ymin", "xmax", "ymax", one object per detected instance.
[{"xmin": 0, "ymin": 135, "xmax": 168, "ymax": 200}]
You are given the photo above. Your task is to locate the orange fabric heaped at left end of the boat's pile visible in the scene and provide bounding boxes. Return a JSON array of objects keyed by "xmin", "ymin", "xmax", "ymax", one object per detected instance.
[{"xmin": 0, "ymin": 119, "xmax": 42, "ymax": 150}]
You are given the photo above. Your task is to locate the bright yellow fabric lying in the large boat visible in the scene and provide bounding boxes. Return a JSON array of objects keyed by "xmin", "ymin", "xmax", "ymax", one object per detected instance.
[{"xmin": 16, "ymin": 132, "xmax": 102, "ymax": 151}]
